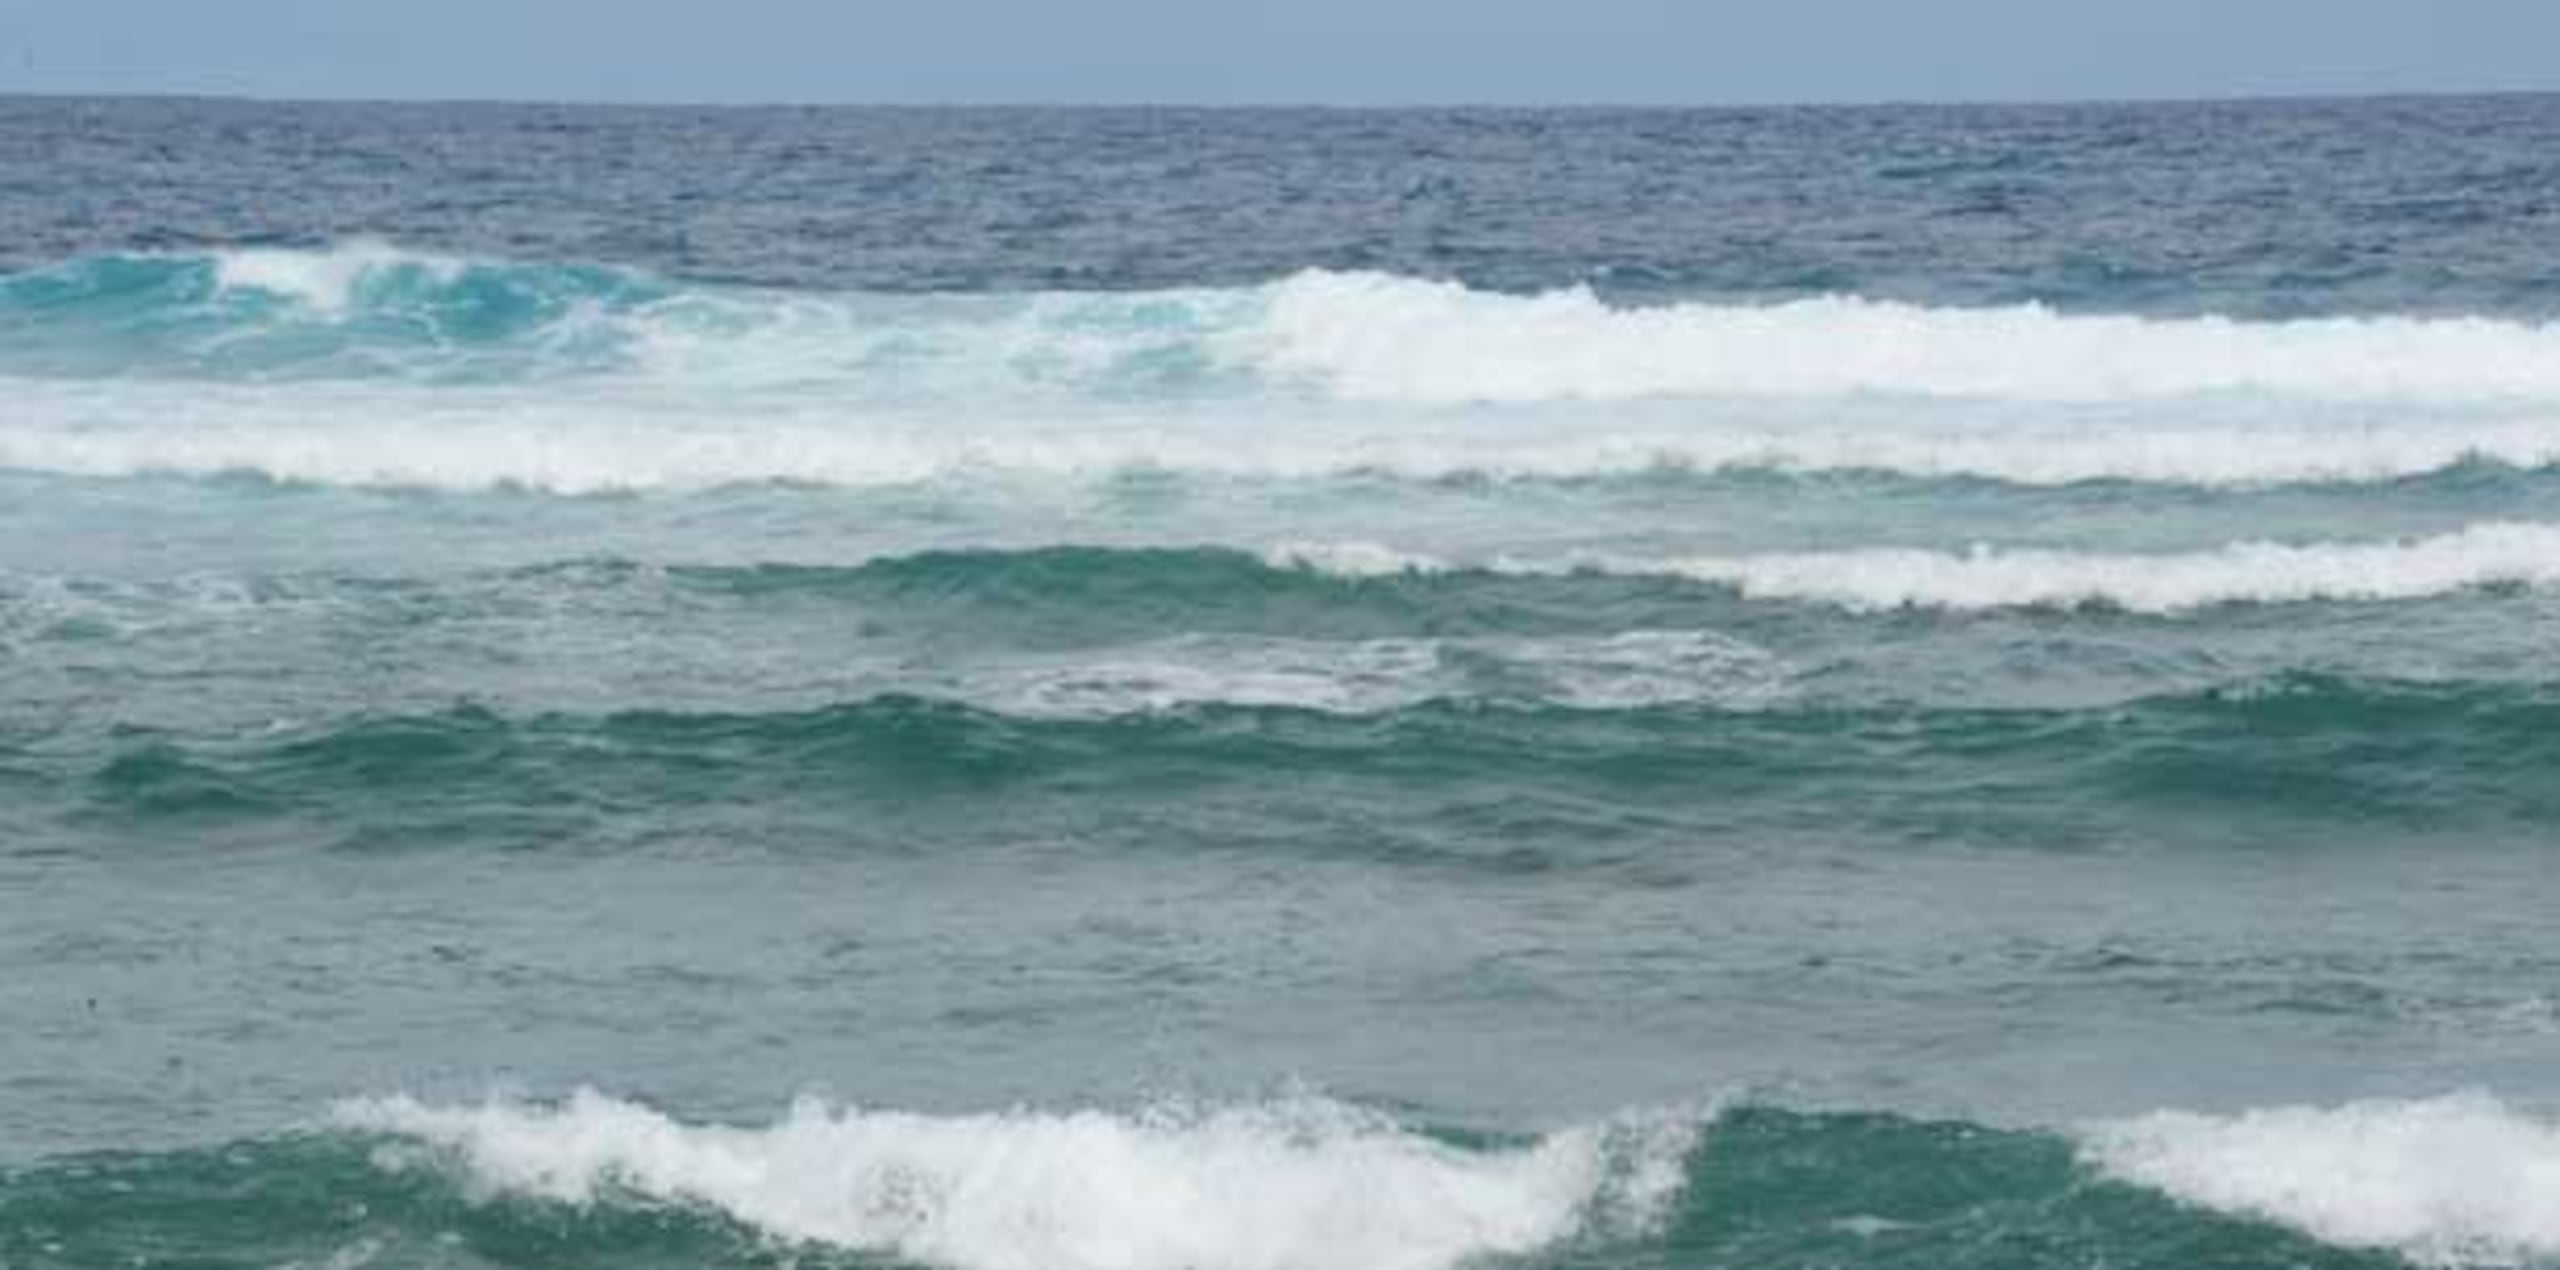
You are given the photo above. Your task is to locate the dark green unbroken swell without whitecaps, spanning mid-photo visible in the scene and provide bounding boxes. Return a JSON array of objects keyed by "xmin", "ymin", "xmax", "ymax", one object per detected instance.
[{"xmin": 79, "ymin": 676, "xmax": 2560, "ymax": 845}]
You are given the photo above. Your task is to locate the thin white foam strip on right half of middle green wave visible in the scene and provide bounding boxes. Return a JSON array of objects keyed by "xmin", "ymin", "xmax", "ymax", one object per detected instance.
[{"xmin": 1267, "ymin": 522, "xmax": 2560, "ymax": 615}]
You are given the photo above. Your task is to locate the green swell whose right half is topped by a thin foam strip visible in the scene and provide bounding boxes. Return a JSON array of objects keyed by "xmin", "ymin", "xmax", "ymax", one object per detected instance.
[{"xmin": 20, "ymin": 540, "xmax": 2560, "ymax": 673}]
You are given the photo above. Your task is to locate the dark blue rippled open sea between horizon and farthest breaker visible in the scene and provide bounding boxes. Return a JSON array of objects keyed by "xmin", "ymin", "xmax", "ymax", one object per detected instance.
[{"xmin": 15, "ymin": 97, "xmax": 2560, "ymax": 315}]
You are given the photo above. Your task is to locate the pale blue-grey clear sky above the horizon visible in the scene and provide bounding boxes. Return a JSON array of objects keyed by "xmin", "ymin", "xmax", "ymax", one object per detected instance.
[{"xmin": 0, "ymin": 0, "xmax": 2560, "ymax": 105}]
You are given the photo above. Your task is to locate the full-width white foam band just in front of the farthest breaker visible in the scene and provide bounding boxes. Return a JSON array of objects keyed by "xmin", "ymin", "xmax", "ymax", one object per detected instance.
[{"xmin": 15, "ymin": 376, "xmax": 2560, "ymax": 494}]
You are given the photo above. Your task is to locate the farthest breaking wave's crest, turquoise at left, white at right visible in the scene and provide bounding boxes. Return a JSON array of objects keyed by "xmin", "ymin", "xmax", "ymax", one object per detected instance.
[{"xmin": 15, "ymin": 241, "xmax": 2560, "ymax": 402}]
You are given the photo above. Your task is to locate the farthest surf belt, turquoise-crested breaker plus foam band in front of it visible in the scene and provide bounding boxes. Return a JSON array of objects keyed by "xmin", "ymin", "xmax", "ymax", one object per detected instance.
[{"xmin": 15, "ymin": 243, "xmax": 2560, "ymax": 492}]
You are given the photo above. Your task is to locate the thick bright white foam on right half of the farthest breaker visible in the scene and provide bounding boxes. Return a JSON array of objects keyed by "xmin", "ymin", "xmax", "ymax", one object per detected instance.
[{"xmin": 1254, "ymin": 274, "xmax": 2560, "ymax": 402}]
